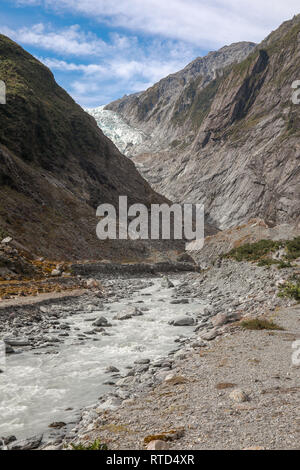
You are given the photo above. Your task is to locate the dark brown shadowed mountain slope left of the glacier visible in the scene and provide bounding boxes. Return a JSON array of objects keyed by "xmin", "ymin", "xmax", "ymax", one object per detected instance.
[{"xmin": 0, "ymin": 35, "xmax": 166, "ymax": 259}]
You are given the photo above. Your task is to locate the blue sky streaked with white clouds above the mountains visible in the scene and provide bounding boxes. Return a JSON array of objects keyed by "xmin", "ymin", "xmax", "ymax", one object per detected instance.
[{"xmin": 0, "ymin": 0, "xmax": 300, "ymax": 107}]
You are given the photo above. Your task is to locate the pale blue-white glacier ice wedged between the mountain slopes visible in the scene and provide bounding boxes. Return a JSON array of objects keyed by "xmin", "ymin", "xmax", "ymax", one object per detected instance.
[{"xmin": 85, "ymin": 106, "xmax": 149, "ymax": 157}]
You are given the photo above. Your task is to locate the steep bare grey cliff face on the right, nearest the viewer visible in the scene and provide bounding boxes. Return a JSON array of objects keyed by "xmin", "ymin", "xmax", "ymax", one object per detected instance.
[{"xmin": 106, "ymin": 15, "xmax": 300, "ymax": 229}]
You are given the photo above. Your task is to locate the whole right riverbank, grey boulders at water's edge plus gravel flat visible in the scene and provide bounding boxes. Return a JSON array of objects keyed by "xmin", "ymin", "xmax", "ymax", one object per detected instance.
[{"xmin": 57, "ymin": 260, "xmax": 300, "ymax": 449}]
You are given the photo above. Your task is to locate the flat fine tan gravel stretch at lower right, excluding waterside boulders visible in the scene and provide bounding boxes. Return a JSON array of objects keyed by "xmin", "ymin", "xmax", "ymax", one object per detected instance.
[{"xmin": 85, "ymin": 306, "xmax": 300, "ymax": 450}]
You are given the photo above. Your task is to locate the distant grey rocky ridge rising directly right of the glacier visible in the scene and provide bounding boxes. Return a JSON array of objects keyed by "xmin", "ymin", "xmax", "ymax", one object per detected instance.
[{"xmin": 105, "ymin": 42, "xmax": 255, "ymax": 155}]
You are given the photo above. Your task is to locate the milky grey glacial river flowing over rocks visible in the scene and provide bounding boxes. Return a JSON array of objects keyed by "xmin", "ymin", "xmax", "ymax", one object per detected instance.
[{"xmin": 0, "ymin": 279, "xmax": 205, "ymax": 439}]
